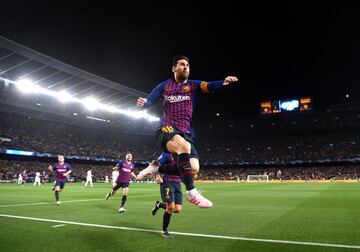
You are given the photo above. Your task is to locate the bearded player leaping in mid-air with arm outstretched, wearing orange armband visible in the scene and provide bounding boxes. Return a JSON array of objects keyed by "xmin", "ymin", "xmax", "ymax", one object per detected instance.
[{"xmin": 137, "ymin": 55, "xmax": 238, "ymax": 208}]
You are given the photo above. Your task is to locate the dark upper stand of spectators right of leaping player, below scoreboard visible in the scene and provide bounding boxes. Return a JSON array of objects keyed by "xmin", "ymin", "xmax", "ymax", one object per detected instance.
[{"xmin": 196, "ymin": 104, "xmax": 360, "ymax": 164}]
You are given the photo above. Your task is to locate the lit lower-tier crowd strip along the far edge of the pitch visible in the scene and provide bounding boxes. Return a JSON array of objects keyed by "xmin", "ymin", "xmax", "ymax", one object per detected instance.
[{"xmin": 0, "ymin": 160, "xmax": 360, "ymax": 182}]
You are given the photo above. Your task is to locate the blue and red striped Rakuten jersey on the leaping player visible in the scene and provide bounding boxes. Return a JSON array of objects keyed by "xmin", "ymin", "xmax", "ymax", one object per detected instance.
[{"xmin": 144, "ymin": 79, "xmax": 224, "ymax": 133}]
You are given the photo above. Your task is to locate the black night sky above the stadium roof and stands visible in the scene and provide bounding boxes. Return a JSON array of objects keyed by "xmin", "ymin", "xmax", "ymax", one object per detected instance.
[{"xmin": 0, "ymin": 1, "xmax": 360, "ymax": 119}]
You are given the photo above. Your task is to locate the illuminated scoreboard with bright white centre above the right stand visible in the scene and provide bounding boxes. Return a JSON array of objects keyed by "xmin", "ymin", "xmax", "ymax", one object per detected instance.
[{"xmin": 260, "ymin": 97, "xmax": 312, "ymax": 114}]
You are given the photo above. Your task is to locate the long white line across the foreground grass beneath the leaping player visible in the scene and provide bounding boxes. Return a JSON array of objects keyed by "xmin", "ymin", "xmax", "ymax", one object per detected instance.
[{"xmin": 0, "ymin": 214, "xmax": 360, "ymax": 249}]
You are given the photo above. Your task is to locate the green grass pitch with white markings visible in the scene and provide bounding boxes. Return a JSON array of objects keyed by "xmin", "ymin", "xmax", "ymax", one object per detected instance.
[{"xmin": 0, "ymin": 183, "xmax": 360, "ymax": 252}]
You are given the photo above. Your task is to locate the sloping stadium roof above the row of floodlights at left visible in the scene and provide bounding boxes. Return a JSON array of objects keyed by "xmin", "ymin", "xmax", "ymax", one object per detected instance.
[{"xmin": 0, "ymin": 36, "xmax": 146, "ymax": 109}]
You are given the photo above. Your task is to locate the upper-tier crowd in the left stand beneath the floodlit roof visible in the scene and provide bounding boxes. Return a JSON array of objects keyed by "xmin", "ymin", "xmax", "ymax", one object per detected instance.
[{"xmin": 0, "ymin": 113, "xmax": 158, "ymax": 161}]
